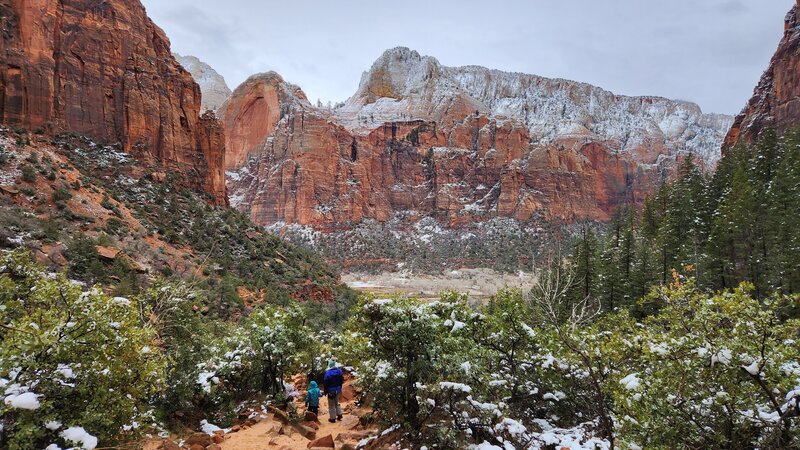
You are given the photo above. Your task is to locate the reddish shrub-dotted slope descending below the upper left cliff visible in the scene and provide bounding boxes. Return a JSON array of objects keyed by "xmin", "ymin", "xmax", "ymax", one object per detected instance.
[{"xmin": 0, "ymin": 127, "xmax": 341, "ymax": 308}]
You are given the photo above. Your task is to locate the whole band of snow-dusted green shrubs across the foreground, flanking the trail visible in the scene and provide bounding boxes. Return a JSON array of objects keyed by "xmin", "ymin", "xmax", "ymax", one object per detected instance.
[{"xmin": 0, "ymin": 251, "xmax": 800, "ymax": 449}]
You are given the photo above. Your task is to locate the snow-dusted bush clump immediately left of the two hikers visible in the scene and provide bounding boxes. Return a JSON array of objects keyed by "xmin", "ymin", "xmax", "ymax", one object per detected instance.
[{"xmin": 147, "ymin": 282, "xmax": 311, "ymax": 425}]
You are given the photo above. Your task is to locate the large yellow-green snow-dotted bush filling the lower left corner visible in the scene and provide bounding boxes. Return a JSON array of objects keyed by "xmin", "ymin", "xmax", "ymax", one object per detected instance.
[{"xmin": 0, "ymin": 252, "xmax": 164, "ymax": 449}]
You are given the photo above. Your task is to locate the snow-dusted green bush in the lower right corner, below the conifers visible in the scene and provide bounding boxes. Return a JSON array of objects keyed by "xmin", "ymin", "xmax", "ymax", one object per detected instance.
[{"xmin": 615, "ymin": 280, "xmax": 800, "ymax": 448}]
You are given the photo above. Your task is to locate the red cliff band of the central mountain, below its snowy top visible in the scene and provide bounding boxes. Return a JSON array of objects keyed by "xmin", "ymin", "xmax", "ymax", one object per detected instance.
[{"xmin": 226, "ymin": 90, "xmax": 660, "ymax": 231}]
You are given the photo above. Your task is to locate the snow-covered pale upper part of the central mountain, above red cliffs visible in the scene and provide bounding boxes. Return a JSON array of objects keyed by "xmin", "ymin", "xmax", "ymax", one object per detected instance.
[{"xmin": 336, "ymin": 47, "xmax": 733, "ymax": 165}]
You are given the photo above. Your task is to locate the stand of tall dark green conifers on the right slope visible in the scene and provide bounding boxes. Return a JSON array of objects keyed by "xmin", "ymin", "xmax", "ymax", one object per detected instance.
[{"xmin": 569, "ymin": 126, "xmax": 800, "ymax": 314}]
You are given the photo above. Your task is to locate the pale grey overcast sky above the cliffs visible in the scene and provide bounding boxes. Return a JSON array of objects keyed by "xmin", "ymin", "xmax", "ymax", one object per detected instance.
[{"xmin": 143, "ymin": 0, "xmax": 794, "ymax": 114}]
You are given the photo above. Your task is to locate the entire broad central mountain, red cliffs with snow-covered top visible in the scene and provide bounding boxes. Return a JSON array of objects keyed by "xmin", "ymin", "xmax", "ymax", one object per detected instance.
[{"xmin": 228, "ymin": 48, "xmax": 731, "ymax": 231}]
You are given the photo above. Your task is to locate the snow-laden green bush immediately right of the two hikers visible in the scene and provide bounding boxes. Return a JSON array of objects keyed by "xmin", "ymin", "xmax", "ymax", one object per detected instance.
[{"xmin": 345, "ymin": 291, "xmax": 608, "ymax": 449}]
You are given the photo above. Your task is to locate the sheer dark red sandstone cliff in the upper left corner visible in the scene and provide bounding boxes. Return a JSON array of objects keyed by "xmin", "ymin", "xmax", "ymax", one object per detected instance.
[{"xmin": 0, "ymin": 0, "xmax": 227, "ymax": 204}]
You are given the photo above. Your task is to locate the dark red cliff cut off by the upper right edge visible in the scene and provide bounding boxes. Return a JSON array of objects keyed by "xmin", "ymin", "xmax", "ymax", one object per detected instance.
[{"xmin": 725, "ymin": 2, "xmax": 800, "ymax": 147}]
